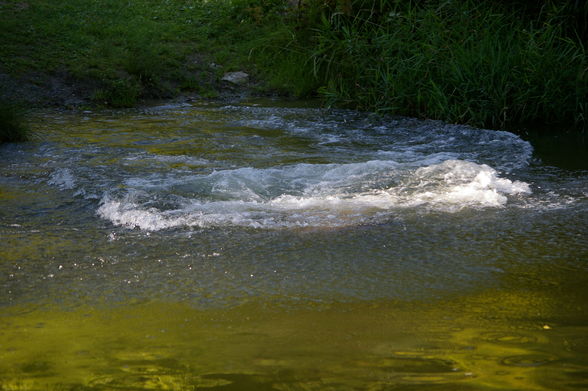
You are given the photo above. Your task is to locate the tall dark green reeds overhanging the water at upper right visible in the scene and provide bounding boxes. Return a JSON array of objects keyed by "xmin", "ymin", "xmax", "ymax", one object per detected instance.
[{"xmin": 262, "ymin": 0, "xmax": 588, "ymax": 129}]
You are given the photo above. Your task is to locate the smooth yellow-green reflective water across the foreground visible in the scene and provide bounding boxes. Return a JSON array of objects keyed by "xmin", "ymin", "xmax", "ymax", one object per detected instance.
[{"xmin": 0, "ymin": 290, "xmax": 588, "ymax": 390}]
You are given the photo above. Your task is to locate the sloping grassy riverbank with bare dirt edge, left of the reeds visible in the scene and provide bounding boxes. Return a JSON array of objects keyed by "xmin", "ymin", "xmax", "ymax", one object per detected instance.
[{"xmin": 0, "ymin": 0, "xmax": 274, "ymax": 108}]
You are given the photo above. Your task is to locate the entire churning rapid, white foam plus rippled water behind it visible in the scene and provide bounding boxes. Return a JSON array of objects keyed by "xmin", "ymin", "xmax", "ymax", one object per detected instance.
[{"xmin": 34, "ymin": 105, "xmax": 544, "ymax": 231}]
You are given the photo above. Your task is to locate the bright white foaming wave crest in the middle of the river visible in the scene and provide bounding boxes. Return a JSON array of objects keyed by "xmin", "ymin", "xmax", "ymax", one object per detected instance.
[{"xmin": 97, "ymin": 160, "xmax": 531, "ymax": 231}]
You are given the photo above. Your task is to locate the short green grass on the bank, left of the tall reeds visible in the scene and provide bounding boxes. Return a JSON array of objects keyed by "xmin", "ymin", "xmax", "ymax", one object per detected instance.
[{"xmin": 0, "ymin": 0, "xmax": 284, "ymax": 107}]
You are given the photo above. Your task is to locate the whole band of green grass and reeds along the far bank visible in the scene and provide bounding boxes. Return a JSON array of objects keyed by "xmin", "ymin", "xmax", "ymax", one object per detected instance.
[{"xmin": 0, "ymin": 0, "xmax": 588, "ymax": 141}]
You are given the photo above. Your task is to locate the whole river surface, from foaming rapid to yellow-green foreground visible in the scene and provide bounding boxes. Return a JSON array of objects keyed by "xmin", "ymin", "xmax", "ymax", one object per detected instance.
[{"xmin": 0, "ymin": 100, "xmax": 588, "ymax": 391}]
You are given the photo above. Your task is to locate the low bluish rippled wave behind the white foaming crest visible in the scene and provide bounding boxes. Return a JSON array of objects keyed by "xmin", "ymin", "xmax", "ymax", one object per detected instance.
[{"xmin": 222, "ymin": 106, "xmax": 533, "ymax": 172}]
